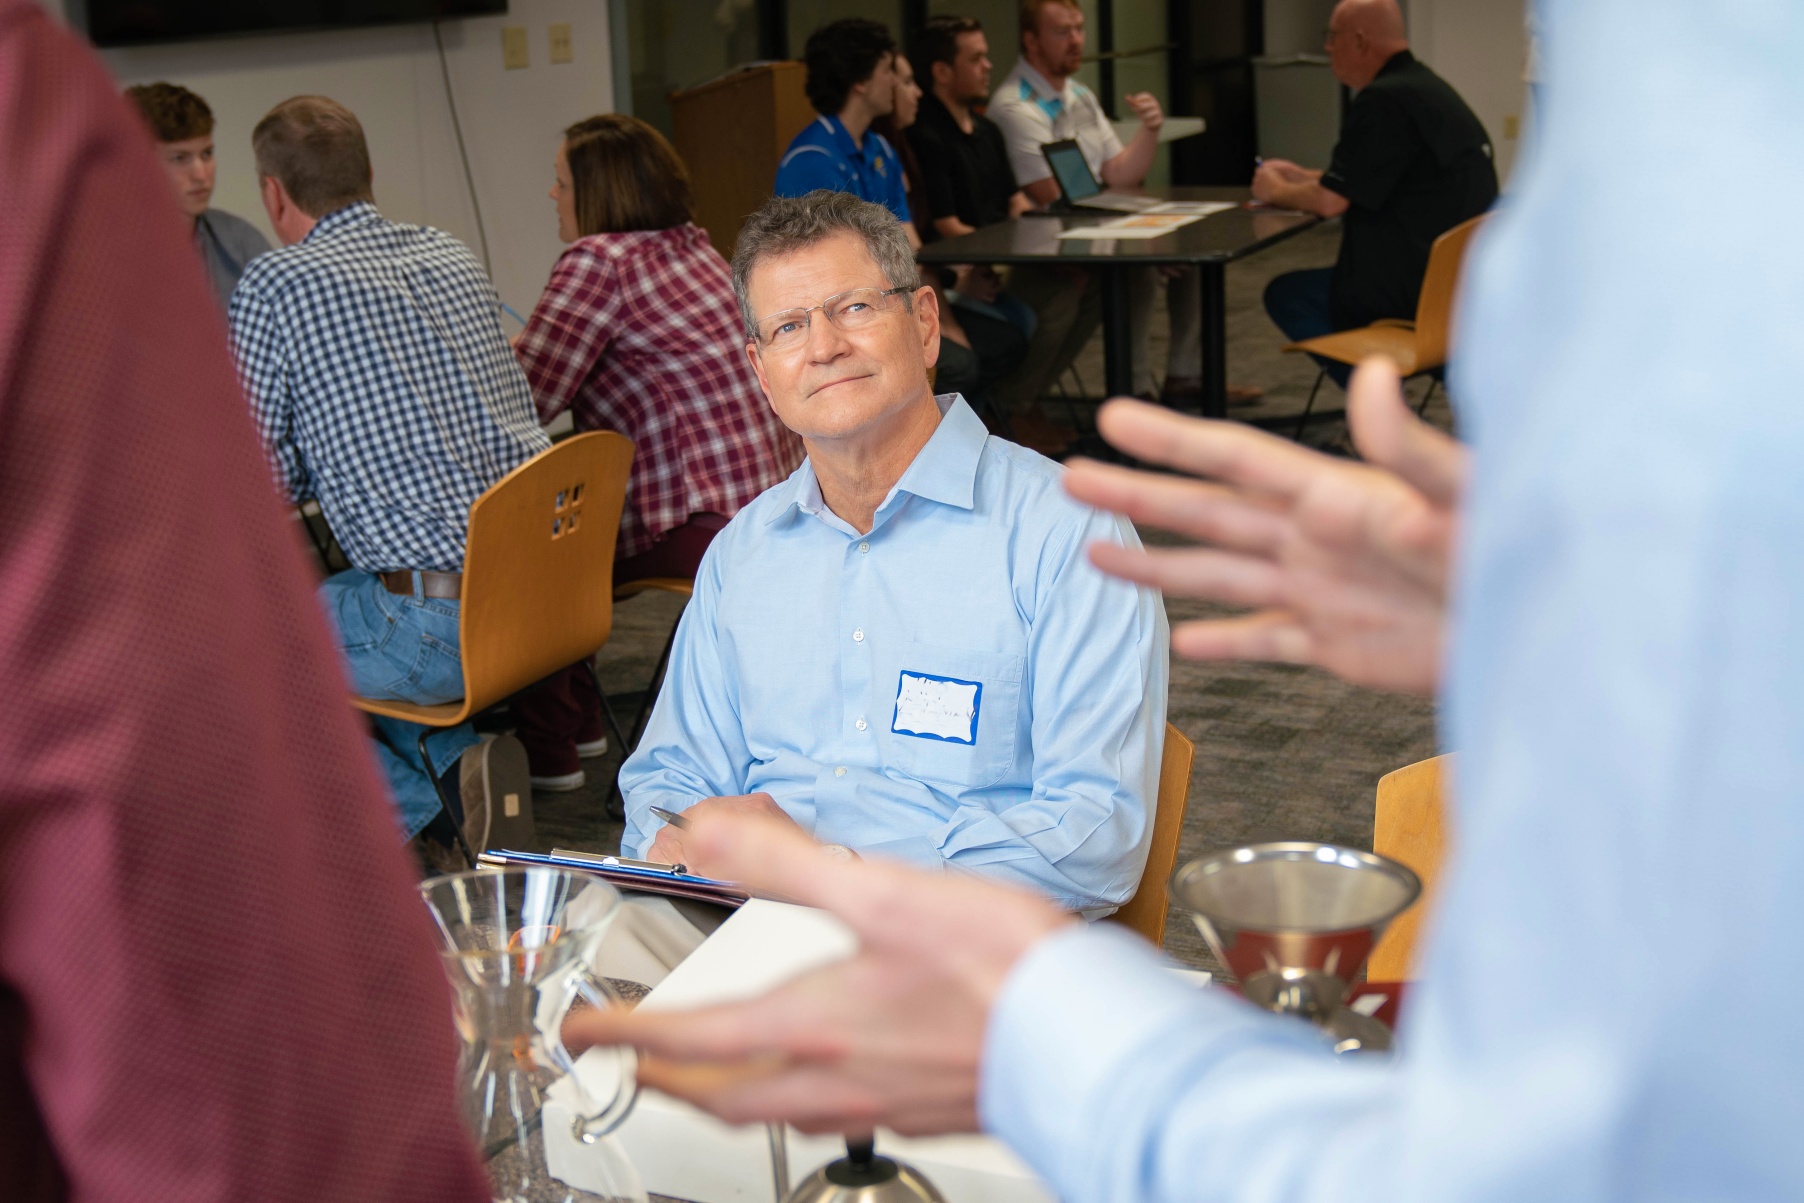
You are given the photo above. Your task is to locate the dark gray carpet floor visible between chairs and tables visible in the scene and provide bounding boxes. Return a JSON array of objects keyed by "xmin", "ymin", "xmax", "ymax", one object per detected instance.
[{"xmin": 534, "ymin": 224, "xmax": 1450, "ymax": 969}]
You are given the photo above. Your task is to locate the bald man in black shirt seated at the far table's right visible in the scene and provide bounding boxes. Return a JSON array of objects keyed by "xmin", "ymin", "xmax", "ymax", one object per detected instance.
[{"xmin": 1252, "ymin": 0, "xmax": 1497, "ymax": 388}]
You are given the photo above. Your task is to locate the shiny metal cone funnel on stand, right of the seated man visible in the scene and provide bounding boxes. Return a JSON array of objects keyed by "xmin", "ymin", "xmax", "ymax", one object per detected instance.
[{"xmin": 1171, "ymin": 842, "xmax": 1422, "ymax": 1051}]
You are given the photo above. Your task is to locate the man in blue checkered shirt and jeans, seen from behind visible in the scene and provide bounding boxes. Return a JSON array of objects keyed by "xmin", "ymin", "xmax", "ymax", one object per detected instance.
[{"xmin": 231, "ymin": 96, "xmax": 550, "ymax": 866}]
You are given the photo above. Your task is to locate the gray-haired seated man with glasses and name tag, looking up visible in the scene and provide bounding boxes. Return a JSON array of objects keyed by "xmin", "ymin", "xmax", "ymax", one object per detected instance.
[{"xmin": 621, "ymin": 195, "xmax": 1167, "ymax": 913}]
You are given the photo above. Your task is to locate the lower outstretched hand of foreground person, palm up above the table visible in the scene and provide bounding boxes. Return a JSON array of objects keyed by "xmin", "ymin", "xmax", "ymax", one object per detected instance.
[{"xmin": 565, "ymin": 815, "xmax": 1075, "ymax": 1134}]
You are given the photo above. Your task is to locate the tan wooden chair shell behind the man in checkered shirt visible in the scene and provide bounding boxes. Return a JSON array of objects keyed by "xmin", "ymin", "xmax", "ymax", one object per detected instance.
[{"xmin": 354, "ymin": 431, "xmax": 633, "ymax": 727}]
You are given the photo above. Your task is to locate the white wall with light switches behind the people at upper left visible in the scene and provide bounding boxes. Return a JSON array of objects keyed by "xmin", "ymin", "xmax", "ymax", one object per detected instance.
[{"xmin": 35, "ymin": 0, "xmax": 613, "ymax": 315}]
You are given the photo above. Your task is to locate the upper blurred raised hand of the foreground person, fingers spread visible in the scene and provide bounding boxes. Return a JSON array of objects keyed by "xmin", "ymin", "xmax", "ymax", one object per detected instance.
[{"xmin": 1064, "ymin": 359, "xmax": 1467, "ymax": 694}]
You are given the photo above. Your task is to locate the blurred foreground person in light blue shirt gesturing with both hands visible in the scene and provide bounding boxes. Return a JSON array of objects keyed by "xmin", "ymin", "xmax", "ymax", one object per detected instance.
[{"xmin": 570, "ymin": 0, "xmax": 1804, "ymax": 1203}]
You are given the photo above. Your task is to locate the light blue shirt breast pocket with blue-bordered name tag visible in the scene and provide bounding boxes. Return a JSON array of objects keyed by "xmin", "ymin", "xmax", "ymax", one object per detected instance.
[{"xmin": 880, "ymin": 642, "xmax": 1026, "ymax": 788}]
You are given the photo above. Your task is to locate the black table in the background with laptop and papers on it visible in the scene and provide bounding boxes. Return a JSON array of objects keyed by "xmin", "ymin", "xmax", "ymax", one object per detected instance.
[{"xmin": 915, "ymin": 188, "xmax": 1321, "ymax": 418}]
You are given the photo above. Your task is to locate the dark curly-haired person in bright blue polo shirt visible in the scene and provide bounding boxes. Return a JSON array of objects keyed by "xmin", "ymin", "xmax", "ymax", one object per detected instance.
[{"xmin": 774, "ymin": 16, "xmax": 920, "ymax": 251}]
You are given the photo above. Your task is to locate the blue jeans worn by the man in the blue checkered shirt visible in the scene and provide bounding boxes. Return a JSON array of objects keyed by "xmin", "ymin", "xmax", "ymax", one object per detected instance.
[{"xmin": 319, "ymin": 568, "xmax": 478, "ymax": 839}]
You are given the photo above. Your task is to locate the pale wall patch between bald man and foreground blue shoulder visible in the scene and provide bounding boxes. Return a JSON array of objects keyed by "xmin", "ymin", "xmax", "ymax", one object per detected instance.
[{"xmin": 1407, "ymin": 0, "xmax": 1528, "ymax": 180}]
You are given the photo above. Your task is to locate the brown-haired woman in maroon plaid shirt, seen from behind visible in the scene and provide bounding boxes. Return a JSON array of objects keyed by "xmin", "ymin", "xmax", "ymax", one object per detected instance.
[{"xmin": 514, "ymin": 114, "xmax": 801, "ymax": 790}]
